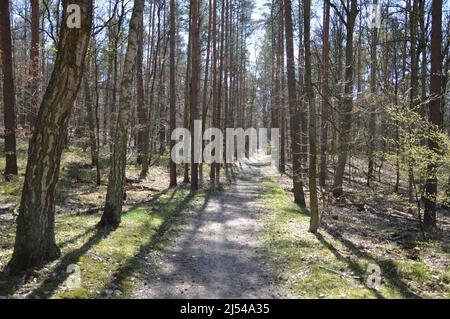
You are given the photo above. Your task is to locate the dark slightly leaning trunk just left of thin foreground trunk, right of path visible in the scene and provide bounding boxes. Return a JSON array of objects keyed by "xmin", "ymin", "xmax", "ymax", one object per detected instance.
[{"xmin": 280, "ymin": 0, "xmax": 306, "ymax": 207}]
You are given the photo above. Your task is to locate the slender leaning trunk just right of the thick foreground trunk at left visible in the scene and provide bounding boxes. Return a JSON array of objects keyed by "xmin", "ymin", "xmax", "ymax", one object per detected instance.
[{"xmin": 99, "ymin": 0, "xmax": 144, "ymax": 227}]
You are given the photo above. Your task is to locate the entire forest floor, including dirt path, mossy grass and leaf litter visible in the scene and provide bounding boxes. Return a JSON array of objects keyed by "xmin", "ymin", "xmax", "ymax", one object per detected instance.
[{"xmin": 0, "ymin": 141, "xmax": 450, "ymax": 298}]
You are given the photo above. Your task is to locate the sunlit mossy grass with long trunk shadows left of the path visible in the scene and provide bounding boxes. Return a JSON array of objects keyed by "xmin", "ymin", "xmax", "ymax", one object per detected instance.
[{"xmin": 0, "ymin": 187, "xmax": 206, "ymax": 298}]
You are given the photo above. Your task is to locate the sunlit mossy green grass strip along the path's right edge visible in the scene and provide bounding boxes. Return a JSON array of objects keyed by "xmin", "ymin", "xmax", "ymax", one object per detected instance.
[{"xmin": 260, "ymin": 179, "xmax": 449, "ymax": 298}]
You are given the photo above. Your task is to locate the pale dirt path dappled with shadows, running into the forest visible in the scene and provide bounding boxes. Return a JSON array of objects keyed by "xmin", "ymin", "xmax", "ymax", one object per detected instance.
[{"xmin": 133, "ymin": 160, "xmax": 280, "ymax": 298}]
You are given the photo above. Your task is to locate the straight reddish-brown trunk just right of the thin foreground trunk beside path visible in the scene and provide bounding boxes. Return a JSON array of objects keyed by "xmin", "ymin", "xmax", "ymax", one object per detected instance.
[{"xmin": 319, "ymin": 0, "xmax": 330, "ymax": 187}]
